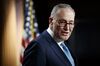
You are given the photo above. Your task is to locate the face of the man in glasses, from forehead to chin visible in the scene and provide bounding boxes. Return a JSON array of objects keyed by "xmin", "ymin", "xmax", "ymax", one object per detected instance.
[{"xmin": 52, "ymin": 8, "xmax": 75, "ymax": 40}]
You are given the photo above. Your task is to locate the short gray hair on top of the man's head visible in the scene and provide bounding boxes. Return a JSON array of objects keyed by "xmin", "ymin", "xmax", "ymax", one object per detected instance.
[{"xmin": 50, "ymin": 4, "xmax": 75, "ymax": 17}]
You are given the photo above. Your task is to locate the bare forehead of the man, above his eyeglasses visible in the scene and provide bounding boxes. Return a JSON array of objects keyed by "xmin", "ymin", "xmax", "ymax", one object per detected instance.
[{"xmin": 56, "ymin": 8, "xmax": 75, "ymax": 20}]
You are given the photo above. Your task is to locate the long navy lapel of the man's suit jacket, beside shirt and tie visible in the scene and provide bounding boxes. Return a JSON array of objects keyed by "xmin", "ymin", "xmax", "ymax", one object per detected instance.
[{"xmin": 43, "ymin": 31, "xmax": 70, "ymax": 65}]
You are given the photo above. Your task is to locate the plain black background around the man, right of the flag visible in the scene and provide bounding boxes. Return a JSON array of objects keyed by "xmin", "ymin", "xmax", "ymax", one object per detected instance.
[{"xmin": 33, "ymin": 0, "xmax": 100, "ymax": 66}]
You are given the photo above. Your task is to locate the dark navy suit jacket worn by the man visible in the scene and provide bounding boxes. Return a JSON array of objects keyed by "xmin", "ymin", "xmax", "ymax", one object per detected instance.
[{"xmin": 23, "ymin": 31, "xmax": 76, "ymax": 66}]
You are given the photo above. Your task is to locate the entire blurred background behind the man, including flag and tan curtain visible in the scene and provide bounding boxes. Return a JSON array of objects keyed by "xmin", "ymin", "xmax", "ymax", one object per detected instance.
[{"xmin": 0, "ymin": 0, "xmax": 100, "ymax": 66}]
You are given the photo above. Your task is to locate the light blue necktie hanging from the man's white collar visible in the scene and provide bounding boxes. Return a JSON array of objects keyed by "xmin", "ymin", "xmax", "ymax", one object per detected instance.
[{"xmin": 60, "ymin": 43, "xmax": 75, "ymax": 66}]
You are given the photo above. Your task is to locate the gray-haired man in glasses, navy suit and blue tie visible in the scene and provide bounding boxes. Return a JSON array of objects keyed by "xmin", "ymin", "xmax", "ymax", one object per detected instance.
[{"xmin": 23, "ymin": 4, "xmax": 76, "ymax": 66}]
